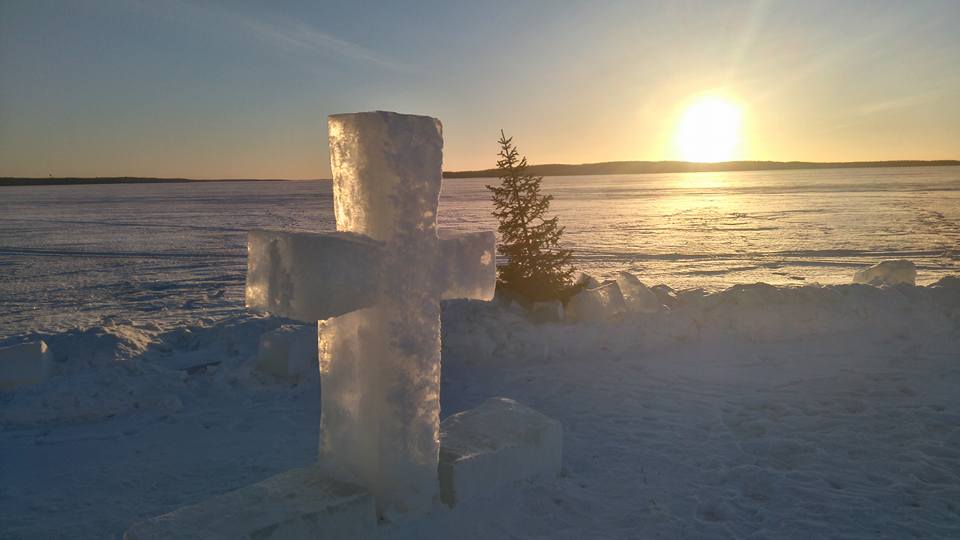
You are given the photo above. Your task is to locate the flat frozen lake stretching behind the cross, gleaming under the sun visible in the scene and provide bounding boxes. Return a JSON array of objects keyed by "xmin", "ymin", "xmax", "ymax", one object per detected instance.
[{"xmin": 0, "ymin": 167, "xmax": 960, "ymax": 339}]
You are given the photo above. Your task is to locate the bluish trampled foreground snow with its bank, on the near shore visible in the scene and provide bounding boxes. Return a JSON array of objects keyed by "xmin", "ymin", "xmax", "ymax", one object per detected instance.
[{"xmin": 0, "ymin": 277, "xmax": 960, "ymax": 539}]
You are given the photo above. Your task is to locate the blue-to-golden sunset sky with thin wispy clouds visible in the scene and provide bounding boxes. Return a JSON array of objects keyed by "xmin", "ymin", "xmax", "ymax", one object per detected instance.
[{"xmin": 0, "ymin": 0, "xmax": 960, "ymax": 179}]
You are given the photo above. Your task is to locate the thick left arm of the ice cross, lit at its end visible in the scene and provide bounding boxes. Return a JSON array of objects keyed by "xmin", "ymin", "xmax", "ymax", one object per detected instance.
[{"xmin": 246, "ymin": 231, "xmax": 383, "ymax": 322}]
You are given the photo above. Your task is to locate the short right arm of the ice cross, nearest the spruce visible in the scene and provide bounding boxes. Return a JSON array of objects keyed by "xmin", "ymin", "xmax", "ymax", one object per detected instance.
[{"xmin": 440, "ymin": 231, "xmax": 497, "ymax": 300}]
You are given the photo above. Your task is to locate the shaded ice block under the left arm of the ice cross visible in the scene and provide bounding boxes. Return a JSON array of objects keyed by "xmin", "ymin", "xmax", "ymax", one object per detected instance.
[{"xmin": 257, "ymin": 325, "xmax": 318, "ymax": 379}]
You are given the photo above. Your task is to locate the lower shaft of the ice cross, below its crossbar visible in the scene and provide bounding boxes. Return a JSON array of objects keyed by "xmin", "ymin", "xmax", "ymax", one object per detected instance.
[{"xmin": 320, "ymin": 304, "xmax": 440, "ymax": 515}]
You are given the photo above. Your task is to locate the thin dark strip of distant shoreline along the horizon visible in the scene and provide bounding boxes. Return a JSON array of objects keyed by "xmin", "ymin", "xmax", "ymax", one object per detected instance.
[{"xmin": 0, "ymin": 159, "xmax": 960, "ymax": 187}]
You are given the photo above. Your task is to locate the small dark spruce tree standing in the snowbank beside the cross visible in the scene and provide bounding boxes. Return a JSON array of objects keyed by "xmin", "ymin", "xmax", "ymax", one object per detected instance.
[{"xmin": 487, "ymin": 130, "xmax": 573, "ymax": 301}]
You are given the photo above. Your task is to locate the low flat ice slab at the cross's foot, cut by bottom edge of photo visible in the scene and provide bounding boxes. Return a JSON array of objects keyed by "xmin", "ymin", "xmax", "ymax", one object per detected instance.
[{"xmin": 123, "ymin": 467, "xmax": 377, "ymax": 540}]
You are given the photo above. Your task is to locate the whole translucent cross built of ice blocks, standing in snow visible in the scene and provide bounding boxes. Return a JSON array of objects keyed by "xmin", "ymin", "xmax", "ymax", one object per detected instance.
[{"xmin": 247, "ymin": 111, "xmax": 496, "ymax": 515}]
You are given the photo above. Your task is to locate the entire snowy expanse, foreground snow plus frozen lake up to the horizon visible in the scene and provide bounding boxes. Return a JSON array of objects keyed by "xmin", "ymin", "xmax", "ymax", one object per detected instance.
[{"xmin": 0, "ymin": 167, "xmax": 960, "ymax": 539}]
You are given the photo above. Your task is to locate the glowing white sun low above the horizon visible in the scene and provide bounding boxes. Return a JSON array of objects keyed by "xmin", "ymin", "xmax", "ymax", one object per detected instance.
[{"xmin": 677, "ymin": 96, "xmax": 741, "ymax": 162}]
